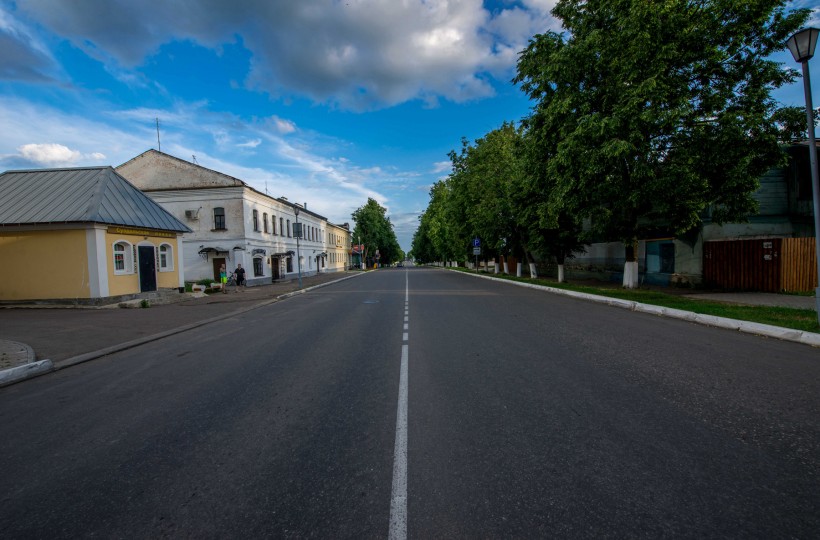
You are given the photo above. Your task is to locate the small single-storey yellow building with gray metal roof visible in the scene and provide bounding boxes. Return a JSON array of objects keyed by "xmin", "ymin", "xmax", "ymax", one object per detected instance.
[{"xmin": 0, "ymin": 167, "xmax": 190, "ymax": 303}]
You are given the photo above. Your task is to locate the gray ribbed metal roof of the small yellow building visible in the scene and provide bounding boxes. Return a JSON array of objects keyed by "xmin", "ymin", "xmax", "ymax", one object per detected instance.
[{"xmin": 0, "ymin": 167, "xmax": 191, "ymax": 232}]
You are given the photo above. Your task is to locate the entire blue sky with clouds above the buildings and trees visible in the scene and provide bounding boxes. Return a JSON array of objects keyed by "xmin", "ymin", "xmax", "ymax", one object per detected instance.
[{"xmin": 0, "ymin": 0, "xmax": 820, "ymax": 250}]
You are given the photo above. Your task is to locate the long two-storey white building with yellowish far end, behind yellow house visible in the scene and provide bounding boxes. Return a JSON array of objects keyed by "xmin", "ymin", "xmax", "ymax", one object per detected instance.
[{"xmin": 117, "ymin": 150, "xmax": 350, "ymax": 285}]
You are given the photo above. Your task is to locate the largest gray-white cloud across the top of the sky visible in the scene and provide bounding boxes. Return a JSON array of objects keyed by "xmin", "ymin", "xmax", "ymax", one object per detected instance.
[{"xmin": 12, "ymin": 0, "xmax": 553, "ymax": 109}]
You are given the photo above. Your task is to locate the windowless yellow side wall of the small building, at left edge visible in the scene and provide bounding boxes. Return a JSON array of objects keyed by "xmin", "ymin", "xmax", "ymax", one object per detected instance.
[{"xmin": 0, "ymin": 230, "xmax": 91, "ymax": 300}]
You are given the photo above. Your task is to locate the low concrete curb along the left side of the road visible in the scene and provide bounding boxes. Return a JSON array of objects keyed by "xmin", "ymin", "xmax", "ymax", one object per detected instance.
[{"xmin": 0, "ymin": 273, "xmax": 364, "ymax": 387}]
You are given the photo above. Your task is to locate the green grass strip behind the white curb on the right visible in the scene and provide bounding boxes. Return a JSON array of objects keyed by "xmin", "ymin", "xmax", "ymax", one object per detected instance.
[{"xmin": 459, "ymin": 268, "xmax": 820, "ymax": 332}]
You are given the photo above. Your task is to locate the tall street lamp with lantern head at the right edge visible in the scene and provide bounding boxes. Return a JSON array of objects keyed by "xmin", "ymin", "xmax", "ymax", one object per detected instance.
[{"xmin": 786, "ymin": 28, "xmax": 820, "ymax": 322}]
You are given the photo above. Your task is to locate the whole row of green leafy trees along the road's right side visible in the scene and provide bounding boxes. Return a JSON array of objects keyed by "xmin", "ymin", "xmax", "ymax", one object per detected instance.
[{"xmin": 412, "ymin": 0, "xmax": 809, "ymax": 288}]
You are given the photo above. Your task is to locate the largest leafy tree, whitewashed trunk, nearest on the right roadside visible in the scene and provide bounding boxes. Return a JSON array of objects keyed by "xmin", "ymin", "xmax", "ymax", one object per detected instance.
[{"xmin": 514, "ymin": 0, "xmax": 808, "ymax": 287}]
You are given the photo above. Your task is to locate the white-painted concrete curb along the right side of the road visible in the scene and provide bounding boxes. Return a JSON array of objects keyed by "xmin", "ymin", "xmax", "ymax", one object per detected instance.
[{"xmin": 452, "ymin": 270, "xmax": 820, "ymax": 347}]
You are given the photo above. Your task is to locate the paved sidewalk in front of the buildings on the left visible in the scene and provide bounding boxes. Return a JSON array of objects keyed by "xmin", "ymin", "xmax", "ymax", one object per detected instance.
[{"xmin": 0, "ymin": 271, "xmax": 362, "ymax": 386}]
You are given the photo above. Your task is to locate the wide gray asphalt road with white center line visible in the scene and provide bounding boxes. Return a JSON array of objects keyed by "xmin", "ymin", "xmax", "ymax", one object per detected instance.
[{"xmin": 0, "ymin": 268, "xmax": 820, "ymax": 538}]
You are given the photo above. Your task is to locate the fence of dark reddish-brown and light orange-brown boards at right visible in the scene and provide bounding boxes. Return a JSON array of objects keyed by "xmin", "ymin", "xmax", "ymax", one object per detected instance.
[{"xmin": 703, "ymin": 238, "xmax": 817, "ymax": 292}]
